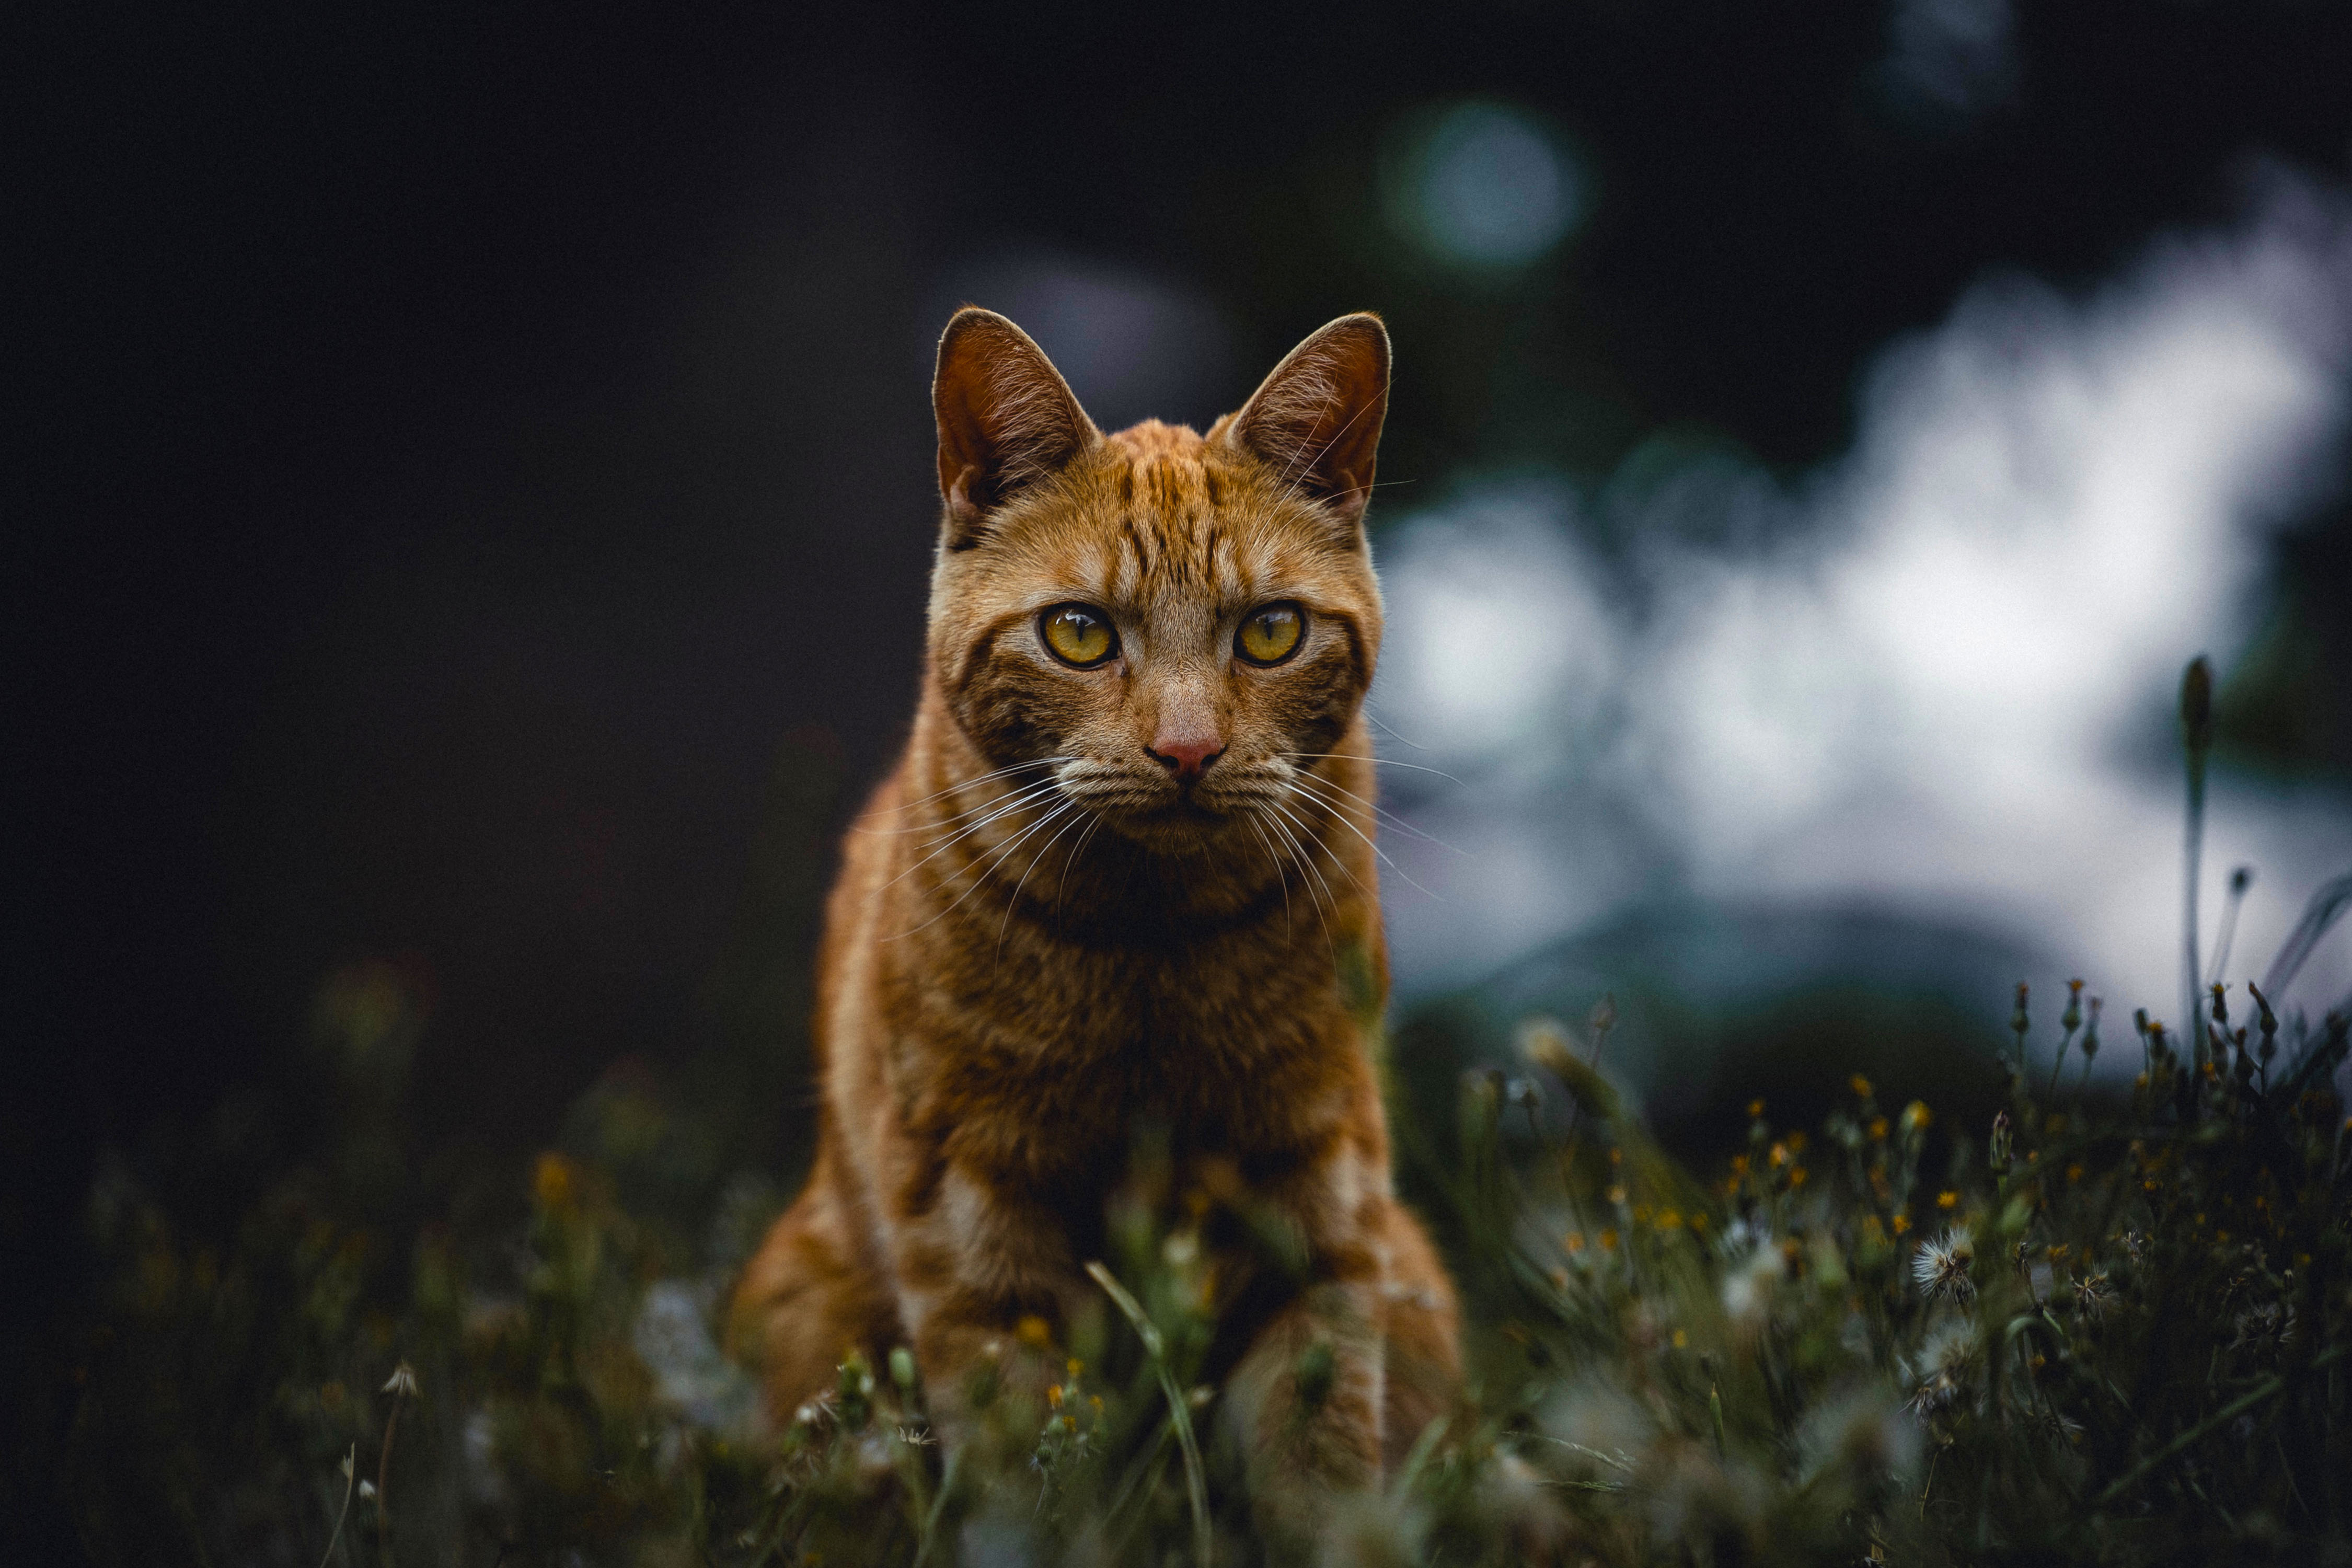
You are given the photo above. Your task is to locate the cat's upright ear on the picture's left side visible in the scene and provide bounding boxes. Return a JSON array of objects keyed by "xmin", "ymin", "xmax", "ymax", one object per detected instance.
[{"xmin": 931, "ymin": 306, "xmax": 1103, "ymax": 550}]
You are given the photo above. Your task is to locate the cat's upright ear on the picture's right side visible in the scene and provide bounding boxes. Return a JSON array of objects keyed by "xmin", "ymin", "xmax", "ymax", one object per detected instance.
[{"xmin": 1221, "ymin": 310, "xmax": 1388, "ymax": 524}]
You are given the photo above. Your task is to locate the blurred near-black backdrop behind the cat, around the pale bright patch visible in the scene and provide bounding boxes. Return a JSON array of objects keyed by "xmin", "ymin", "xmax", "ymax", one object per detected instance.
[{"xmin": 14, "ymin": 0, "xmax": 2352, "ymax": 1551}]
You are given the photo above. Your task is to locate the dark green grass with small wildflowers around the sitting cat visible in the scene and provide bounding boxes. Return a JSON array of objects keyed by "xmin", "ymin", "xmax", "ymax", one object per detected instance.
[{"xmin": 37, "ymin": 667, "xmax": 2352, "ymax": 1568}]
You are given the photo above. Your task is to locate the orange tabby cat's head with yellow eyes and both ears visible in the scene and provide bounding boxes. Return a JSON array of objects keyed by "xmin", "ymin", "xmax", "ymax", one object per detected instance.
[{"xmin": 929, "ymin": 308, "xmax": 1388, "ymax": 846}]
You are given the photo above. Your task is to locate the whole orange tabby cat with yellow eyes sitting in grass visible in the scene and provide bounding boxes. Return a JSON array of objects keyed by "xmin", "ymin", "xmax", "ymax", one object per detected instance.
[{"xmin": 732, "ymin": 308, "xmax": 1458, "ymax": 1528}]
